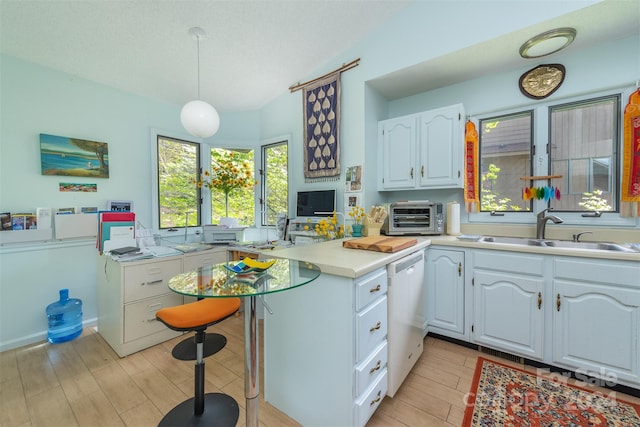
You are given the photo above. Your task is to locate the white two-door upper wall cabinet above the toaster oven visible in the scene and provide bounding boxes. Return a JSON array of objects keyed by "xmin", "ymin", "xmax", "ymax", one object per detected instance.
[{"xmin": 378, "ymin": 104, "xmax": 464, "ymax": 191}]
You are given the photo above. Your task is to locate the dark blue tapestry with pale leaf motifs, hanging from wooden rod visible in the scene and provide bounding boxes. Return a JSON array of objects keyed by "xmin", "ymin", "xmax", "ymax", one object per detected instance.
[{"xmin": 289, "ymin": 58, "xmax": 360, "ymax": 182}]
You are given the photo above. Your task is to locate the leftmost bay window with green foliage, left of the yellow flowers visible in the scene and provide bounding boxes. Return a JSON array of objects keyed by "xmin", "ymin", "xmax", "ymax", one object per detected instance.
[{"xmin": 156, "ymin": 135, "xmax": 200, "ymax": 229}]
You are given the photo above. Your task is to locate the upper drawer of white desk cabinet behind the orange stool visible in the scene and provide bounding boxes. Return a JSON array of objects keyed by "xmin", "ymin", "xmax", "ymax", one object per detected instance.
[{"xmin": 124, "ymin": 259, "xmax": 182, "ymax": 304}]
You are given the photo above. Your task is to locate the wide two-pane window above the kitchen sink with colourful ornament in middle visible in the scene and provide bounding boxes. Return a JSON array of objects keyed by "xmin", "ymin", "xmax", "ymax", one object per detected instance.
[{"xmin": 479, "ymin": 96, "xmax": 620, "ymax": 212}]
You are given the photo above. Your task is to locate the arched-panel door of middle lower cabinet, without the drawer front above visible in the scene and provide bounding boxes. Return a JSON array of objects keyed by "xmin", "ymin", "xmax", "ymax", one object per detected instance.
[{"xmin": 473, "ymin": 270, "xmax": 544, "ymax": 359}]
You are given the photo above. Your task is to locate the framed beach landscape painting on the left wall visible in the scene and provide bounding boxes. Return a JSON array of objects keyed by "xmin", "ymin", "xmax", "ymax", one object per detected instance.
[{"xmin": 40, "ymin": 133, "xmax": 109, "ymax": 178}]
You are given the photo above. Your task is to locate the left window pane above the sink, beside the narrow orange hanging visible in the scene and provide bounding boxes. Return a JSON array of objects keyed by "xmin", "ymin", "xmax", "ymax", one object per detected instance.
[{"xmin": 480, "ymin": 111, "xmax": 533, "ymax": 212}]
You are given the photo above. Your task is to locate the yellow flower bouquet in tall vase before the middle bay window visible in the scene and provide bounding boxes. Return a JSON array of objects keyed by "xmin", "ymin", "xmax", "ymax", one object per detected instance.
[{"xmin": 192, "ymin": 150, "xmax": 257, "ymax": 217}]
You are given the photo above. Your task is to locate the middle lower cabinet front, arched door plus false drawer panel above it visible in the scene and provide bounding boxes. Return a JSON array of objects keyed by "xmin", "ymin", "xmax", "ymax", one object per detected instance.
[{"xmin": 472, "ymin": 250, "xmax": 545, "ymax": 360}]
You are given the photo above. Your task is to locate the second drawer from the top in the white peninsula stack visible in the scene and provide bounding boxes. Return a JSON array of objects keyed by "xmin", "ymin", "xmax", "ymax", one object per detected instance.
[{"xmin": 356, "ymin": 296, "xmax": 387, "ymax": 362}]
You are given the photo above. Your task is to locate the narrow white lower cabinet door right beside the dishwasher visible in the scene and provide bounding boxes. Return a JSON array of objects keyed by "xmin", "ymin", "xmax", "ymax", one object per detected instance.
[{"xmin": 426, "ymin": 249, "xmax": 464, "ymax": 338}]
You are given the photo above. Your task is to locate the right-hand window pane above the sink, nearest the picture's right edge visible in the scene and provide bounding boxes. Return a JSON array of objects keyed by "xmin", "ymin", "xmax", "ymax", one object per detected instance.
[{"xmin": 549, "ymin": 96, "xmax": 620, "ymax": 212}]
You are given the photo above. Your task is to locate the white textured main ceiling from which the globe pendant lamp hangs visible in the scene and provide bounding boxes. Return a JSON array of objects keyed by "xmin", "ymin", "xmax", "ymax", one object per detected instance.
[{"xmin": 0, "ymin": 0, "xmax": 411, "ymax": 111}]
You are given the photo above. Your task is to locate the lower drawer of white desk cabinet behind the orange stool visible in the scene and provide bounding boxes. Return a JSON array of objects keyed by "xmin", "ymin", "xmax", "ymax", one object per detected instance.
[{"xmin": 124, "ymin": 293, "xmax": 182, "ymax": 342}]
